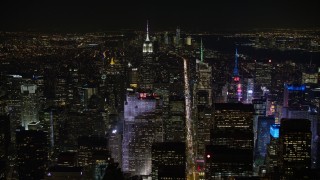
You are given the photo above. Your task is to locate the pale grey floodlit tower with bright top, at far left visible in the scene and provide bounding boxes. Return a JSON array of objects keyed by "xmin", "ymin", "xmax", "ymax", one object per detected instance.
[{"xmin": 21, "ymin": 84, "xmax": 39, "ymax": 130}]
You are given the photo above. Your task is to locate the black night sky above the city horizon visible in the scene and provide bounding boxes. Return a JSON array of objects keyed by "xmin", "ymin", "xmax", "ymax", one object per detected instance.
[{"xmin": 0, "ymin": 0, "xmax": 320, "ymax": 32}]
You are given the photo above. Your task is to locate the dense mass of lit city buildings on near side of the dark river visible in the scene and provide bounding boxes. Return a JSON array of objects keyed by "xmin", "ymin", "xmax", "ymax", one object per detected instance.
[{"xmin": 0, "ymin": 25, "xmax": 320, "ymax": 180}]
